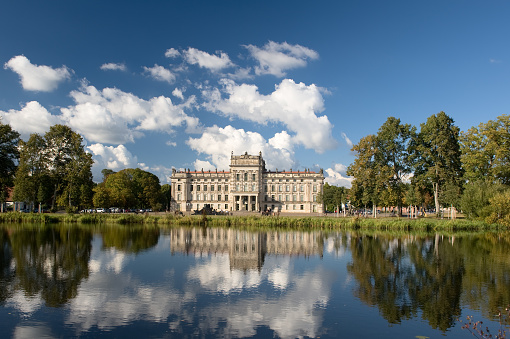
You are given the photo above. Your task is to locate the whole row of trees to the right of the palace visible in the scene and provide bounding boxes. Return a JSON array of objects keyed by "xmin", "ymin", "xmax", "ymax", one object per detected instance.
[{"xmin": 323, "ymin": 112, "xmax": 510, "ymax": 225}]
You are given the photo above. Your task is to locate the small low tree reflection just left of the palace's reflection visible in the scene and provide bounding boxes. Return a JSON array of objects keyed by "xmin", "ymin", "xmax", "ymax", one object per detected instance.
[{"xmin": 101, "ymin": 225, "xmax": 159, "ymax": 254}]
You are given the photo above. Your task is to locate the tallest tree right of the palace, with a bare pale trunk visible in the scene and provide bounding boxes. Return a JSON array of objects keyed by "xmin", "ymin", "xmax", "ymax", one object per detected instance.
[{"xmin": 412, "ymin": 112, "xmax": 463, "ymax": 213}]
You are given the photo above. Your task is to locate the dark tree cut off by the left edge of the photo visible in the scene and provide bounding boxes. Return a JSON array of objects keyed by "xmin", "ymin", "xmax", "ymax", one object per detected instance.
[{"xmin": 0, "ymin": 121, "xmax": 20, "ymax": 206}]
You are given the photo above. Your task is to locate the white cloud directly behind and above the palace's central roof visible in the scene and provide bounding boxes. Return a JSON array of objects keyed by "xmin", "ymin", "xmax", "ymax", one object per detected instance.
[{"xmin": 186, "ymin": 125, "xmax": 295, "ymax": 170}]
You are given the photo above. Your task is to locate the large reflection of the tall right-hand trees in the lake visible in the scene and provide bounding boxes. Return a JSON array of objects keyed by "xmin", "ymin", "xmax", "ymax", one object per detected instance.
[{"xmin": 348, "ymin": 235, "xmax": 464, "ymax": 331}]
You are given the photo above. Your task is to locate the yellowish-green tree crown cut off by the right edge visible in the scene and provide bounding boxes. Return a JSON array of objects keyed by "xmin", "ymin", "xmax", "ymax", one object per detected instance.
[{"xmin": 461, "ymin": 115, "xmax": 510, "ymax": 185}]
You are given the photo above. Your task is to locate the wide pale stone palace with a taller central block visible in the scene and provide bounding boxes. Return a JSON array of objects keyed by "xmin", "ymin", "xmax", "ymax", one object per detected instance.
[{"xmin": 171, "ymin": 153, "xmax": 324, "ymax": 213}]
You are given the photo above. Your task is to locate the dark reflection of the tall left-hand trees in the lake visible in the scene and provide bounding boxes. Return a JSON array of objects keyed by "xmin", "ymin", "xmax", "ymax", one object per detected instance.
[{"xmin": 10, "ymin": 226, "xmax": 92, "ymax": 307}]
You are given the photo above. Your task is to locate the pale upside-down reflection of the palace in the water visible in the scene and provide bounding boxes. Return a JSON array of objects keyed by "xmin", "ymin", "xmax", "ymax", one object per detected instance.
[{"xmin": 170, "ymin": 228, "xmax": 324, "ymax": 271}]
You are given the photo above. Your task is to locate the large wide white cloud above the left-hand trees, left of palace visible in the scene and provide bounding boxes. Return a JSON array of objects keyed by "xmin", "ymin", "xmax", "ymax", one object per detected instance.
[{"xmin": 61, "ymin": 86, "xmax": 198, "ymax": 144}]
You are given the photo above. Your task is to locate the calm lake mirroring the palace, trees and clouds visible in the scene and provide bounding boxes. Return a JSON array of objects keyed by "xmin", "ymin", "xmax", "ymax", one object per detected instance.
[{"xmin": 0, "ymin": 225, "xmax": 510, "ymax": 338}]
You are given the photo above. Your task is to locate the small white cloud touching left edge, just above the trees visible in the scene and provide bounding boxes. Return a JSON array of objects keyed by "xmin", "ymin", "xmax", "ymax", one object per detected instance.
[{"xmin": 0, "ymin": 101, "xmax": 63, "ymax": 140}]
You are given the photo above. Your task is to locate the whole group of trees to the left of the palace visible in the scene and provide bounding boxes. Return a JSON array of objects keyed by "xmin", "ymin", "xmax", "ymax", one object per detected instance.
[{"xmin": 0, "ymin": 121, "xmax": 170, "ymax": 212}]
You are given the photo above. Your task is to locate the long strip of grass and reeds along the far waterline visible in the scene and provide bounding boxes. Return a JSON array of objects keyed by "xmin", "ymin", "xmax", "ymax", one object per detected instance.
[{"xmin": 0, "ymin": 212, "xmax": 510, "ymax": 232}]
